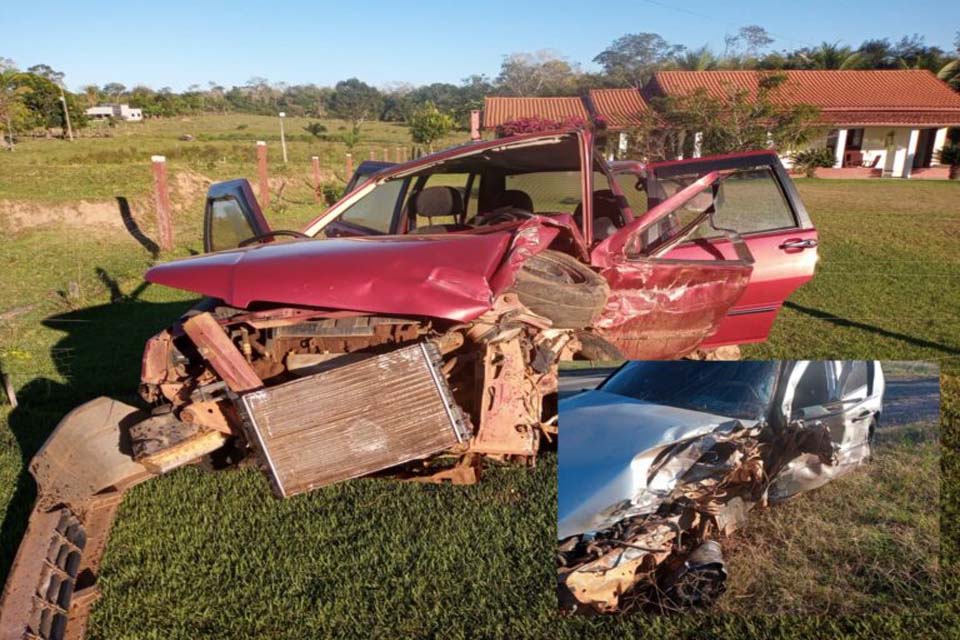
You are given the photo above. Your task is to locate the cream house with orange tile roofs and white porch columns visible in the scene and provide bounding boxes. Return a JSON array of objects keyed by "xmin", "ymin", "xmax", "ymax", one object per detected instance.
[{"xmin": 483, "ymin": 69, "xmax": 960, "ymax": 178}]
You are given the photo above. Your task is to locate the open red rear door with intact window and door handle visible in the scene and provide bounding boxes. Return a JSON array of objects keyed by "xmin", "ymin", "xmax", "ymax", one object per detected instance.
[{"xmin": 645, "ymin": 151, "xmax": 817, "ymax": 348}]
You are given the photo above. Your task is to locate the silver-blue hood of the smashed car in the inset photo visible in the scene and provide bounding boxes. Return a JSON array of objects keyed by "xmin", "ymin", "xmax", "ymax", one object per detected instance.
[{"xmin": 557, "ymin": 391, "xmax": 731, "ymax": 540}]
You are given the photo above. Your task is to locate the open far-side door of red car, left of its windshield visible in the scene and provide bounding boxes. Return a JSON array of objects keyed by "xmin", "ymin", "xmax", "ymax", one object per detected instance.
[{"xmin": 203, "ymin": 178, "xmax": 270, "ymax": 253}]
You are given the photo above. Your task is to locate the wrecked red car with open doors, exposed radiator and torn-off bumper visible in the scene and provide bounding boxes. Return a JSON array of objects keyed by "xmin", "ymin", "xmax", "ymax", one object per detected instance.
[{"xmin": 0, "ymin": 129, "xmax": 817, "ymax": 638}]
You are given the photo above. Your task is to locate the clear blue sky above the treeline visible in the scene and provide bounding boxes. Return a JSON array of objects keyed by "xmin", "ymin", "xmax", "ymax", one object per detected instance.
[{"xmin": 0, "ymin": 0, "xmax": 960, "ymax": 90}]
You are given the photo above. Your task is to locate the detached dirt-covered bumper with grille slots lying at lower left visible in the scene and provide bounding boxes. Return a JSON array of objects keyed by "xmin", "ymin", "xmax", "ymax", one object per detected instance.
[{"xmin": 0, "ymin": 398, "xmax": 153, "ymax": 640}]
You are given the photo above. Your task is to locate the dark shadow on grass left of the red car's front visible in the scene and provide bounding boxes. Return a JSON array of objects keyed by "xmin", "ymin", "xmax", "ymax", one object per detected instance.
[{"xmin": 0, "ymin": 280, "xmax": 195, "ymax": 584}]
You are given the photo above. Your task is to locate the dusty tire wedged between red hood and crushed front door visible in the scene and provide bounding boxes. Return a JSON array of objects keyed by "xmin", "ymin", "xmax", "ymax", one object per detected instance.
[{"xmin": 510, "ymin": 249, "xmax": 610, "ymax": 329}]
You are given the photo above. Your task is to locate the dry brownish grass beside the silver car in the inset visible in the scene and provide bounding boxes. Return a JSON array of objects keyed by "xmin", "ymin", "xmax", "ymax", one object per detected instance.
[{"xmin": 718, "ymin": 425, "xmax": 940, "ymax": 615}]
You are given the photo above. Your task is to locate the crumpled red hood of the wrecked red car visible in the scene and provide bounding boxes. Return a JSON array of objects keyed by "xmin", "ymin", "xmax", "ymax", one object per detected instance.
[{"xmin": 146, "ymin": 230, "xmax": 513, "ymax": 321}]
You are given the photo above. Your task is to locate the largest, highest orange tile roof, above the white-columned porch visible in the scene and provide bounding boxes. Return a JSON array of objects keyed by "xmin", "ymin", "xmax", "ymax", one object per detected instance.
[{"xmin": 645, "ymin": 69, "xmax": 960, "ymax": 126}]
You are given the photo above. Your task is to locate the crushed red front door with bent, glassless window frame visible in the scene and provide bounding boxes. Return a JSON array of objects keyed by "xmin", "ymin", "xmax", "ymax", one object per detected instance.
[{"xmin": 590, "ymin": 172, "xmax": 754, "ymax": 360}]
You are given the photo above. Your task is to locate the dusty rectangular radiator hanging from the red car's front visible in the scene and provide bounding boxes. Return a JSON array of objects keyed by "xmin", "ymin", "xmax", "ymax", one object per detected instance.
[{"xmin": 241, "ymin": 343, "xmax": 469, "ymax": 497}]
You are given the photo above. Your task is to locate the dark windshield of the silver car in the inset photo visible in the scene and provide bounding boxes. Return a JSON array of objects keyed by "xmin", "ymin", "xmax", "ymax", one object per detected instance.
[{"xmin": 599, "ymin": 361, "xmax": 777, "ymax": 420}]
